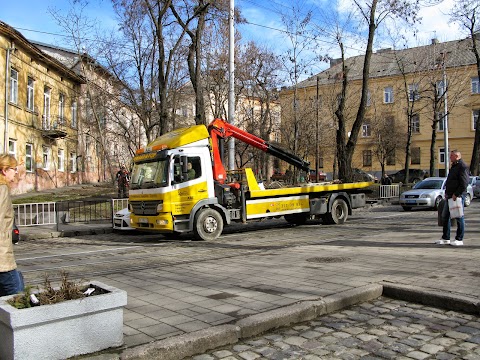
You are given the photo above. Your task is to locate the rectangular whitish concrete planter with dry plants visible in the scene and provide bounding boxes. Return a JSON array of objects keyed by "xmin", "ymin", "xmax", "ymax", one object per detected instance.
[{"xmin": 0, "ymin": 282, "xmax": 127, "ymax": 360}]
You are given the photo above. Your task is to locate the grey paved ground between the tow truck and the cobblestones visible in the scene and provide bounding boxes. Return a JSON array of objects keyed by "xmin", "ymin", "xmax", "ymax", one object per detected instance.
[{"xmin": 13, "ymin": 202, "xmax": 480, "ymax": 360}]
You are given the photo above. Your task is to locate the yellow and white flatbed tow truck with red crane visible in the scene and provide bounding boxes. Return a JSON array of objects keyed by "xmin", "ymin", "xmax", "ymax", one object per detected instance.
[{"xmin": 129, "ymin": 119, "xmax": 371, "ymax": 240}]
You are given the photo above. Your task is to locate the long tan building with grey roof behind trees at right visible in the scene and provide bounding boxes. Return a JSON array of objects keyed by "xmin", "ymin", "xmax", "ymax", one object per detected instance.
[{"xmin": 281, "ymin": 39, "xmax": 480, "ymax": 177}]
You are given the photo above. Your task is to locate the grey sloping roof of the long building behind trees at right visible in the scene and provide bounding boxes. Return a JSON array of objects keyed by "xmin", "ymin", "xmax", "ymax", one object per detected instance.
[{"xmin": 298, "ymin": 38, "xmax": 480, "ymax": 88}]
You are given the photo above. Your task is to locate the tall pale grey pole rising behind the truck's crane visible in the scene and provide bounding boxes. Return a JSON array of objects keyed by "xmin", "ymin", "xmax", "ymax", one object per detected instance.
[{"xmin": 228, "ymin": 0, "xmax": 235, "ymax": 170}]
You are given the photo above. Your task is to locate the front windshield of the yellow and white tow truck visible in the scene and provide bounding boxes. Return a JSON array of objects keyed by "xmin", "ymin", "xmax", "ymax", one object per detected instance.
[{"xmin": 130, "ymin": 159, "xmax": 168, "ymax": 190}]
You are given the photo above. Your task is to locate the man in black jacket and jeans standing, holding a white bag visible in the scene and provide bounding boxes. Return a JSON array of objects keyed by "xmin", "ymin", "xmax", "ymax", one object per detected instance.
[{"xmin": 435, "ymin": 150, "xmax": 468, "ymax": 246}]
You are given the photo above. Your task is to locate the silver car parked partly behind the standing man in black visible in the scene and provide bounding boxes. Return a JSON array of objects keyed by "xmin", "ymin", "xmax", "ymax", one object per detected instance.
[{"xmin": 400, "ymin": 177, "xmax": 473, "ymax": 211}]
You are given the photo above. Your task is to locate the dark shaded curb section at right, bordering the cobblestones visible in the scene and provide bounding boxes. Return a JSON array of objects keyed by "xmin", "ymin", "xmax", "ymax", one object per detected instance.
[{"xmin": 381, "ymin": 282, "xmax": 480, "ymax": 315}]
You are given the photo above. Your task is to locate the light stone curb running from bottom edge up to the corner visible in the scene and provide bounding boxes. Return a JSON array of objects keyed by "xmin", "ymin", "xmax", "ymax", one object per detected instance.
[{"xmin": 120, "ymin": 284, "xmax": 382, "ymax": 360}]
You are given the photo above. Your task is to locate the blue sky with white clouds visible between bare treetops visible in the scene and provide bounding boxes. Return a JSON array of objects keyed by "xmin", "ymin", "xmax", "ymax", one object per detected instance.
[{"xmin": 0, "ymin": 0, "xmax": 463, "ymax": 56}]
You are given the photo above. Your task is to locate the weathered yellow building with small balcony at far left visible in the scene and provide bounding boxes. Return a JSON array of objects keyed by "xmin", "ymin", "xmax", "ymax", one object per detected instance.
[{"xmin": 0, "ymin": 21, "xmax": 83, "ymax": 193}]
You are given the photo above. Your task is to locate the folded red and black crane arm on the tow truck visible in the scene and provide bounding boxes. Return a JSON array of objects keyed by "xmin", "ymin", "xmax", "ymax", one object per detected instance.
[{"xmin": 208, "ymin": 119, "xmax": 310, "ymax": 183}]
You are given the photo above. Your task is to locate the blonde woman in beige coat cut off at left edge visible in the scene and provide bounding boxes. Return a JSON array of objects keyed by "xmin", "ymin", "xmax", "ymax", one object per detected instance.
[{"xmin": 0, "ymin": 154, "xmax": 23, "ymax": 296}]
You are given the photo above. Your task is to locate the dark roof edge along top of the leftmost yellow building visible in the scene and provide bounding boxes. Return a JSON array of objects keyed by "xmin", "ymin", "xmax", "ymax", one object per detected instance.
[{"xmin": 0, "ymin": 20, "xmax": 85, "ymax": 84}]
